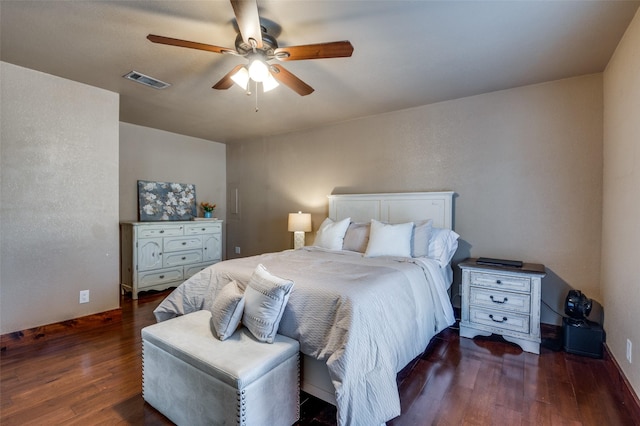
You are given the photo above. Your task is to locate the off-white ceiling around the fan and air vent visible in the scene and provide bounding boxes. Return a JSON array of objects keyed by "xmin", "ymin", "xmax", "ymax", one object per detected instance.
[{"xmin": 0, "ymin": 0, "xmax": 640, "ymax": 143}]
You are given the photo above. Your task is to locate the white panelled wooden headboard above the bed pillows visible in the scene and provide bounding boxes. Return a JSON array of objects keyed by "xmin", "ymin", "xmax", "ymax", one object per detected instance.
[{"xmin": 329, "ymin": 191, "xmax": 454, "ymax": 229}]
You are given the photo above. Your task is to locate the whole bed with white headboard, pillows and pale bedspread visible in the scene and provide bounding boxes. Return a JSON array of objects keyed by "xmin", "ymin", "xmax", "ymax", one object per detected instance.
[{"xmin": 154, "ymin": 192, "xmax": 458, "ymax": 425}]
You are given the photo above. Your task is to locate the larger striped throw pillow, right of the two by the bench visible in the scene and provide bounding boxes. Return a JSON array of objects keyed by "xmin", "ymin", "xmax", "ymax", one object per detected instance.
[{"xmin": 242, "ymin": 264, "xmax": 293, "ymax": 343}]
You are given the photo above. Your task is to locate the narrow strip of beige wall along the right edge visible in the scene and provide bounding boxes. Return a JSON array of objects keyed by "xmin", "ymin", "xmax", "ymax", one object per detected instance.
[{"xmin": 601, "ymin": 7, "xmax": 640, "ymax": 395}]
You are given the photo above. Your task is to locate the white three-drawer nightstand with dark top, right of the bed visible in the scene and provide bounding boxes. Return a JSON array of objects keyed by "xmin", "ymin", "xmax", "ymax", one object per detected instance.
[{"xmin": 458, "ymin": 259, "xmax": 546, "ymax": 354}]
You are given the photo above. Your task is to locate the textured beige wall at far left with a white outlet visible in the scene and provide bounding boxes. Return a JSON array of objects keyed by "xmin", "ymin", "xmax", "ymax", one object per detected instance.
[{"xmin": 0, "ymin": 62, "xmax": 119, "ymax": 334}]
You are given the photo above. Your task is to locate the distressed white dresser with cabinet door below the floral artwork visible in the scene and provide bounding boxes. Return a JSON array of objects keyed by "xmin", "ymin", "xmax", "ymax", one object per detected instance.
[{"xmin": 120, "ymin": 220, "xmax": 222, "ymax": 299}]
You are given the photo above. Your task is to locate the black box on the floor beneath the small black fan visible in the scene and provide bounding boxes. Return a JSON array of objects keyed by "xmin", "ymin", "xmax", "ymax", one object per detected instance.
[{"xmin": 562, "ymin": 318, "xmax": 606, "ymax": 358}]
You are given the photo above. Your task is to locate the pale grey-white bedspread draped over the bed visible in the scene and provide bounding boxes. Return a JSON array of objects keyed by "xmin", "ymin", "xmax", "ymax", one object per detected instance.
[{"xmin": 154, "ymin": 247, "xmax": 454, "ymax": 425}]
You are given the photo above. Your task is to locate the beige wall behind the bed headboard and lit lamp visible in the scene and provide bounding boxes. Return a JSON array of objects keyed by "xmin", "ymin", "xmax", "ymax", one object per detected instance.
[{"xmin": 227, "ymin": 74, "xmax": 603, "ymax": 323}]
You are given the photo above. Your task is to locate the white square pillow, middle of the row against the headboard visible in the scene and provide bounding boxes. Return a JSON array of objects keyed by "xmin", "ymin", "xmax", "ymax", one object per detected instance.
[{"xmin": 364, "ymin": 219, "xmax": 413, "ymax": 257}]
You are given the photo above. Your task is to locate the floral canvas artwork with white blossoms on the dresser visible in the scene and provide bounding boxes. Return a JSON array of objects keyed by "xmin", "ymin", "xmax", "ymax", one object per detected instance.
[{"xmin": 138, "ymin": 180, "xmax": 197, "ymax": 222}]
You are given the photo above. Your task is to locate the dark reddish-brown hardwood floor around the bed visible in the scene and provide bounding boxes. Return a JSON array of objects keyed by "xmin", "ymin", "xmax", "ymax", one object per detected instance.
[{"xmin": 0, "ymin": 292, "xmax": 640, "ymax": 426}]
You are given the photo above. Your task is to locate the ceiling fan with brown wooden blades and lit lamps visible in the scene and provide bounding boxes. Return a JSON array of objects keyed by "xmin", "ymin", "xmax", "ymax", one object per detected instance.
[{"xmin": 147, "ymin": 0, "xmax": 353, "ymax": 96}]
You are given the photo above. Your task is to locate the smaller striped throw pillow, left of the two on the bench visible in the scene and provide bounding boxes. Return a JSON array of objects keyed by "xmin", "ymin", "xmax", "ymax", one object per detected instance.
[{"xmin": 211, "ymin": 281, "xmax": 244, "ymax": 340}]
